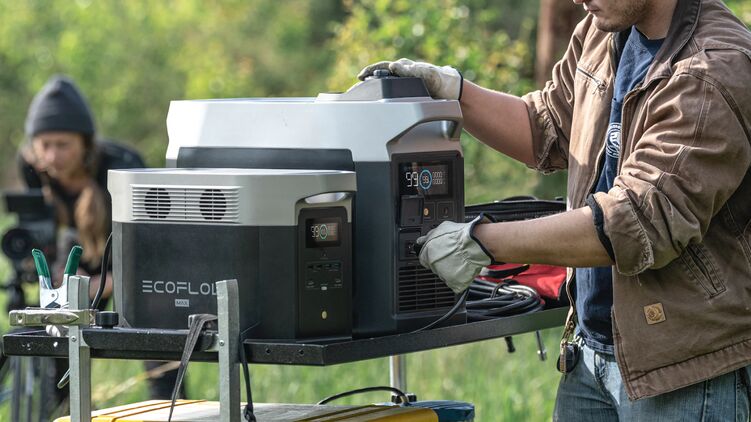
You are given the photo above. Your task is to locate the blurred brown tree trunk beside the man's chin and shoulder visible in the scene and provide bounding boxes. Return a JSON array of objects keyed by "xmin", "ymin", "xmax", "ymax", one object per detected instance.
[{"xmin": 535, "ymin": 0, "xmax": 584, "ymax": 87}]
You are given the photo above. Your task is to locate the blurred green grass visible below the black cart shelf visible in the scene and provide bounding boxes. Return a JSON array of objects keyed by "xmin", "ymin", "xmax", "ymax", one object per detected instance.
[{"xmin": 0, "ymin": 216, "xmax": 560, "ymax": 421}]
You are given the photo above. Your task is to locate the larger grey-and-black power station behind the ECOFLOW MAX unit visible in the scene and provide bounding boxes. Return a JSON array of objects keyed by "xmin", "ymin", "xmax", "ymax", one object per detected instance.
[{"xmin": 167, "ymin": 76, "xmax": 466, "ymax": 336}]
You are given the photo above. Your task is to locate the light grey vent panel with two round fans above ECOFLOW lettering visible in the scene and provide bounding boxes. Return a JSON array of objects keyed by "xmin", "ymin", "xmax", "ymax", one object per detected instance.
[{"xmin": 132, "ymin": 186, "xmax": 240, "ymax": 223}]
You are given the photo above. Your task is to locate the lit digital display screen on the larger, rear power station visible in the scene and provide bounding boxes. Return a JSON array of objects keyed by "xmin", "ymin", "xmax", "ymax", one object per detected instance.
[{"xmin": 399, "ymin": 163, "xmax": 451, "ymax": 196}]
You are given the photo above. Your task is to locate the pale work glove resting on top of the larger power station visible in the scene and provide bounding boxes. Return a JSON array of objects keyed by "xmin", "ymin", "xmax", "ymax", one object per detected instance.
[{"xmin": 357, "ymin": 59, "xmax": 463, "ymax": 100}]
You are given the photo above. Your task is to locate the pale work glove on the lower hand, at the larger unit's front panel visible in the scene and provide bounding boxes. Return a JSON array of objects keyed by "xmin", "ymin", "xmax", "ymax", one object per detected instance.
[{"xmin": 417, "ymin": 214, "xmax": 494, "ymax": 294}]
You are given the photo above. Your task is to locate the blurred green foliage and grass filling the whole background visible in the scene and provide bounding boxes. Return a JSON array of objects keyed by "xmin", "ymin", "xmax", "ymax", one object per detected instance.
[{"xmin": 0, "ymin": 0, "xmax": 751, "ymax": 421}]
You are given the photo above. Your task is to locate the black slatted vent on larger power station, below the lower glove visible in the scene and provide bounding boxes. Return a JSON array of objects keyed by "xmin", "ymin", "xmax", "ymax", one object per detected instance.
[{"xmin": 398, "ymin": 265, "xmax": 455, "ymax": 312}]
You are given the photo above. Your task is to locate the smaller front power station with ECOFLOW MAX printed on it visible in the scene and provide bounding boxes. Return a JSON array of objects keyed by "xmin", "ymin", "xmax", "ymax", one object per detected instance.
[{"xmin": 108, "ymin": 169, "xmax": 356, "ymax": 339}]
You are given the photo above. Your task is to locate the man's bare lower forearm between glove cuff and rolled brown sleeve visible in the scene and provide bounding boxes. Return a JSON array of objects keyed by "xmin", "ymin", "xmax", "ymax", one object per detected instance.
[{"xmin": 474, "ymin": 207, "xmax": 613, "ymax": 267}]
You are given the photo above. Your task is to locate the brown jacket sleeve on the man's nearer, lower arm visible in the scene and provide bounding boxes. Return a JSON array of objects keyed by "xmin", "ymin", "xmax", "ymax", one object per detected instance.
[{"xmin": 594, "ymin": 73, "xmax": 751, "ymax": 275}]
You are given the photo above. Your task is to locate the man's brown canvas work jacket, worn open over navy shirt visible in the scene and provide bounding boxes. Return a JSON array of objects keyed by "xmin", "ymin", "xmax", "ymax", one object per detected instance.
[{"xmin": 524, "ymin": 0, "xmax": 751, "ymax": 400}]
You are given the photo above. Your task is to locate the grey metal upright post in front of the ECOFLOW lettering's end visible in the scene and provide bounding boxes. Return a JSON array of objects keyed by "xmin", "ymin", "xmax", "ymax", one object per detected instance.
[{"xmin": 216, "ymin": 280, "xmax": 241, "ymax": 422}]
